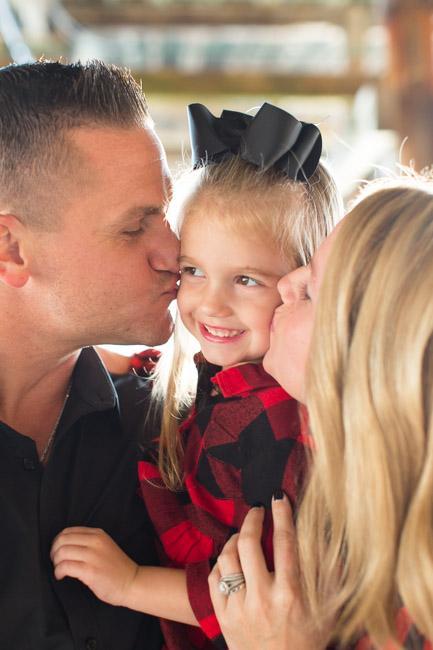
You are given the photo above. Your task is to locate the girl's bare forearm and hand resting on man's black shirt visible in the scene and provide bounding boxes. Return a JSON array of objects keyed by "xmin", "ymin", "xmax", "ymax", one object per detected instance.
[{"xmin": 50, "ymin": 526, "xmax": 198, "ymax": 625}]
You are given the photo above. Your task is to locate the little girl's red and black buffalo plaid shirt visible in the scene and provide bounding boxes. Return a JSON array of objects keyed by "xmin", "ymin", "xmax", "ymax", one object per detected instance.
[{"xmin": 139, "ymin": 358, "xmax": 306, "ymax": 650}]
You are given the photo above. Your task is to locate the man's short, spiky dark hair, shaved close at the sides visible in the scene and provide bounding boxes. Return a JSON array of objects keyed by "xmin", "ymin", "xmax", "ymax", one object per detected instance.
[{"xmin": 0, "ymin": 60, "xmax": 152, "ymax": 229}]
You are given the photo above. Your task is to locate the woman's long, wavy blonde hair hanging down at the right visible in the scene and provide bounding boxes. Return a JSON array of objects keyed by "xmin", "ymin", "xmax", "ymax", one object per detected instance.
[{"xmin": 297, "ymin": 179, "xmax": 433, "ymax": 646}]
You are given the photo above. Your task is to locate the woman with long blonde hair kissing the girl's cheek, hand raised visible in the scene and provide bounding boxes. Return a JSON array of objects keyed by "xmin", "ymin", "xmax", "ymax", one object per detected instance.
[{"xmin": 210, "ymin": 178, "xmax": 433, "ymax": 650}]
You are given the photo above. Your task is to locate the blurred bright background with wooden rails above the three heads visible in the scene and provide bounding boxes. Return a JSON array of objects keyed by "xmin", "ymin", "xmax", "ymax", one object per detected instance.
[{"xmin": 0, "ymin": 0, "xmax": 433, "ymax": 352}]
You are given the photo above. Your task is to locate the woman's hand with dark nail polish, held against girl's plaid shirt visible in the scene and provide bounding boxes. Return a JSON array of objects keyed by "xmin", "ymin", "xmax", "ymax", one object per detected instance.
[{"xmin": 209, "ymin": 495, "xmax": 327, "ymax": 650}]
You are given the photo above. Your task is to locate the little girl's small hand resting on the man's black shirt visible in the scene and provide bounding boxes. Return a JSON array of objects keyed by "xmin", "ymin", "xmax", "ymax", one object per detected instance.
[{"xmin": 50, "ymin": 526, "xmax": 138, "ymax": 605}]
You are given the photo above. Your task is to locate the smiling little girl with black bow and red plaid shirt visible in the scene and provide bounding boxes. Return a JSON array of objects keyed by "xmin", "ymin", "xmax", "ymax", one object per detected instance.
[{"xmin": 52, "ymin": 104, "xmax": 340, "ymax": 650}]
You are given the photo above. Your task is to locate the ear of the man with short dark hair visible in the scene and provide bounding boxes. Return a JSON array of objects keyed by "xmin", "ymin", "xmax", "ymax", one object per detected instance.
[{"xmin": 0, "ymin": 214, "xmax": 29, "ymax": 289}]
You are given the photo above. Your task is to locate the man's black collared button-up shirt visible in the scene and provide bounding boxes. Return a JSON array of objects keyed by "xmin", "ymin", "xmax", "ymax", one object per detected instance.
[{"xmin": 0, "ymin": 348, "xmax": 161, "ymax": 650}]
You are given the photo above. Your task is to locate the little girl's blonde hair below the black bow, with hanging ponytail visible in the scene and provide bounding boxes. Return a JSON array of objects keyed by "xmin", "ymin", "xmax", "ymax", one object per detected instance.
[{"xmin": 153, "ymin": 155, "xmax": 342, "ymax": 489}]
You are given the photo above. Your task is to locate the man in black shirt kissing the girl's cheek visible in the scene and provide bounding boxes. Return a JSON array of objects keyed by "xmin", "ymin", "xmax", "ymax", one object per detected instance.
[{"xmin": 0, "ymin": 61, "xmax": 178, "ymax": 650}]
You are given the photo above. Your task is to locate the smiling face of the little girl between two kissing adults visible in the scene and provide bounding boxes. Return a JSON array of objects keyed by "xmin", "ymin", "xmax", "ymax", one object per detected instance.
[{"xmin": 178, "ymin": 214, "xmax": 289, "ymax": 368}]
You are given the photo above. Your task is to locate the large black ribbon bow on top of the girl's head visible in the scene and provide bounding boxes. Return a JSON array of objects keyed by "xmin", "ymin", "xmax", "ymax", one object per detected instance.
[{"xmin": 188, "ymin": 102, "xmax": 322, "ymax": 181}]
